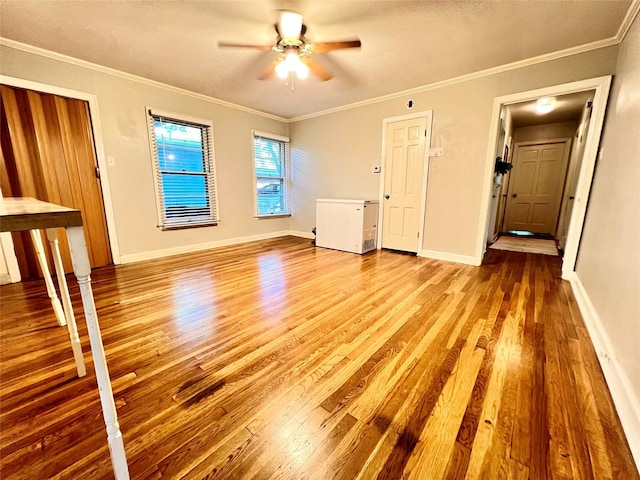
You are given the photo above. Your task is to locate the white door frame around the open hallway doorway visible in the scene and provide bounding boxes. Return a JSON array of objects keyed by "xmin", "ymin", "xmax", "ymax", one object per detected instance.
[{"xmin": 475, "ymin": 75, "xmax": 612, "ymax": 279}]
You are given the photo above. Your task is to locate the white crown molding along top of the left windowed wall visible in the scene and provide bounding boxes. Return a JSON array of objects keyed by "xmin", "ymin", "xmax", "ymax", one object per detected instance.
[{"xmin": 0, "ymin": 37, "xmax": 289, "ymax": 123}]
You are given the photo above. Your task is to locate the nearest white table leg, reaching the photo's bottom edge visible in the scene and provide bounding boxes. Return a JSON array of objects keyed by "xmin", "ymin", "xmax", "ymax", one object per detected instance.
[{"xmin": 67, "ymin": 227, "xmax": 129, "ymax": 480}]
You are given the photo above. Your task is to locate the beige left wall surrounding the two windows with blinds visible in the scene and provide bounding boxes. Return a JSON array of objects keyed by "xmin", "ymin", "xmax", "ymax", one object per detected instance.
[{"xmin": 0, "ymin": 46, "xmax": 289, "ymax": 260}]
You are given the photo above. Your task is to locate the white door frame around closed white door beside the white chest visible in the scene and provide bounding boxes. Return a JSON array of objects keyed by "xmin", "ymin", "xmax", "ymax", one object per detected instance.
[{"xmin": 376, "ymin": 110, "xmax": 433, "ymax": 251}]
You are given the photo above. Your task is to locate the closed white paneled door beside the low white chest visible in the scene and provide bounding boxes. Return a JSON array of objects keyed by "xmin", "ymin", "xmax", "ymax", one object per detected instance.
[{"xmin": 382, "ymin": 117, "xmax": 427, "ymax": 252}]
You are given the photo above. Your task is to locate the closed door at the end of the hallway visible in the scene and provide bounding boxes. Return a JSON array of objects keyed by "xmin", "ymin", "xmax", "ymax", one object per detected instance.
[{"xmin": 505, "ymin": 141, "xmax": 569, "ymax": 235}]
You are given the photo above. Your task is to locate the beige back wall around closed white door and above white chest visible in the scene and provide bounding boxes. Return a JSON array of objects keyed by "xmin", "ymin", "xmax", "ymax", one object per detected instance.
[{"xmin": 290, "ymin": 47, "xmax": 617, "ymax": 257}]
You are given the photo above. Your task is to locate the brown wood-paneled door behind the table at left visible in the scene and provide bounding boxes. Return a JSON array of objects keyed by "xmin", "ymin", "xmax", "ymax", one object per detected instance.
[{"xmin": 0, "ymin": 85, "xmax": 112, "ymax": 278}]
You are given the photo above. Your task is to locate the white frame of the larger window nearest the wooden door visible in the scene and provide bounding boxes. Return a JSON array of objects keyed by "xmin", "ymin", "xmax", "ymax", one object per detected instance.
[{"xmin": 146, "ymin": 107, "xmax": 220, "ymax": 230}]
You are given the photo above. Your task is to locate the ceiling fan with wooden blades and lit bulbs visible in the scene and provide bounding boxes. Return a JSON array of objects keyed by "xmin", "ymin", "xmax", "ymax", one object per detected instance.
[{"xmin": 218, "ymin": 10, "xmax": 362, "ymax": 81}]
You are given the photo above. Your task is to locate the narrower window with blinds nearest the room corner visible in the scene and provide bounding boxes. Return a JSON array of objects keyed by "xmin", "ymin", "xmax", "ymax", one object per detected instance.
[{"xmin": 253, "ymin": 131, "xmax": 291, "ymax": 217}]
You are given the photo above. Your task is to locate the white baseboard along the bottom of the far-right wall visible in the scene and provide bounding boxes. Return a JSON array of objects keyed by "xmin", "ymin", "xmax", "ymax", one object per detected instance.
[{"xmin": 567, "ymin": 272, "xmax": 640, "ymax": 470}]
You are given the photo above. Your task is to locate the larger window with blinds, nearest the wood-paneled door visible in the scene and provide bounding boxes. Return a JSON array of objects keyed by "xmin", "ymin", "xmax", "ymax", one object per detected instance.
[{"xmin": 149, "ymin": 110, "xmax": 218, "ymax": 229}]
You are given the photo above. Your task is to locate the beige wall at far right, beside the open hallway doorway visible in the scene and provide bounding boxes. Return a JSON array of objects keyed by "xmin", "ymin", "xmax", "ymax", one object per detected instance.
[{"xmin": 576, "ymin": 14, "xmax": 640, "ymax": 446}]
